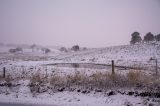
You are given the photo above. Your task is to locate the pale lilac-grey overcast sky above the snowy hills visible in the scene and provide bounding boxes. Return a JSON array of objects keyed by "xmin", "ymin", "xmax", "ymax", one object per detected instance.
[{"xmin": 0, "ymin": 0, "xmax": 160, "ymax": 47}]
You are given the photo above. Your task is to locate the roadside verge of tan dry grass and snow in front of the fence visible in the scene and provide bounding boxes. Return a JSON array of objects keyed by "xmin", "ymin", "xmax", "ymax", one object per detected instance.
[{"xmin": 0, "ymin": 71, "xmax": 160, "ymax": 106}]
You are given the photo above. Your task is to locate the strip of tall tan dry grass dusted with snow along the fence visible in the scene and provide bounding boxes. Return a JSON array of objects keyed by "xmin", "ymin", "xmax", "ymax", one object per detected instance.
[{"xmin": 26, "ymin": 71, "xmax": 160, "ymax": 93}]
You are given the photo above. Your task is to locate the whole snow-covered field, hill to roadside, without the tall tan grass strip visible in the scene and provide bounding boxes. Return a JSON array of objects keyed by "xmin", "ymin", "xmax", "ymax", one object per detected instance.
[{"xmin": 0, "ymin": 43, "xmax": 160, "ymax": 106}]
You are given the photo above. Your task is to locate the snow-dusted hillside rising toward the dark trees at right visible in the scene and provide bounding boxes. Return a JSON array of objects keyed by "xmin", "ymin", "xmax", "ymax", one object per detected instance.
[{"xmin": 55, "ymin": 43, "xmax": 160, "ymax": 70}]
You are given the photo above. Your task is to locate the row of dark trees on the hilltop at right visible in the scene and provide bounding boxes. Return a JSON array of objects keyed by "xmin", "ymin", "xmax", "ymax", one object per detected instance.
[{"xmin": 130, "ymin": 32, "xmax": 160, "ymax": 44}]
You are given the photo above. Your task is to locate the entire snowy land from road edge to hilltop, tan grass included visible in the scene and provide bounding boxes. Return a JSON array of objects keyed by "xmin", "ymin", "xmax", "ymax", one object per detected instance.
[{"xmin": 0, "ymin": 44, "xmax": 160, "ymax": 106}]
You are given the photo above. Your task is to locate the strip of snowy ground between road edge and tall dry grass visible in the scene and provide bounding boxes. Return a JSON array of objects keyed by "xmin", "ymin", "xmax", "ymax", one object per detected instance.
[{"xmin": 0, "ymin": 88, "xmax": 160, "ymax": 106}]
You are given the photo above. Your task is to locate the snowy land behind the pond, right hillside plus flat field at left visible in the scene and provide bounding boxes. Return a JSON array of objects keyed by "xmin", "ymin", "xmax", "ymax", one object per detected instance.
[{"xmin": 0, "ymin": 43, "xmax": 160, "ymax": 74}]
